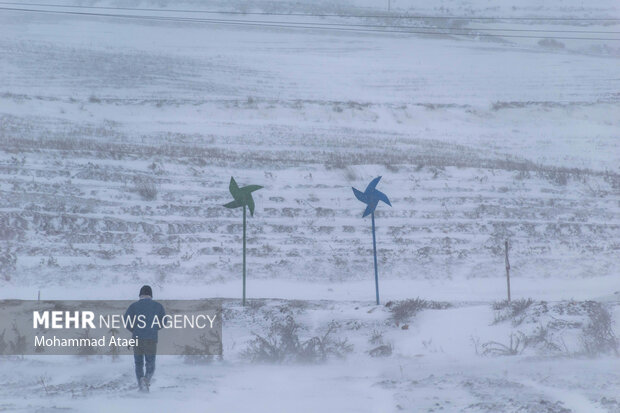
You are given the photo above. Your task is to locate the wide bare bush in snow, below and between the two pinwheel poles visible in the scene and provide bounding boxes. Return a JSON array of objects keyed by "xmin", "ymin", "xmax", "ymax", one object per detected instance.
[{"xmin": 242, "ymin": 315, "xmax": 353, "ymax": 363}]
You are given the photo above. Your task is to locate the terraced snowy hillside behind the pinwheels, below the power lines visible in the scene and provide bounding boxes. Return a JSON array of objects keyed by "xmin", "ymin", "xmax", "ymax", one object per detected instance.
[{"xmin": 0, "ymin": 0, "xmax": 620, "ymax": 298}]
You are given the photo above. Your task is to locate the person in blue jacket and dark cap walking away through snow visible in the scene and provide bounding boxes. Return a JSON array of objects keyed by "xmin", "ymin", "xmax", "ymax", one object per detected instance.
[{"xmin": 125, "ymin": 285, "xmax": 166, "ymax": 392}]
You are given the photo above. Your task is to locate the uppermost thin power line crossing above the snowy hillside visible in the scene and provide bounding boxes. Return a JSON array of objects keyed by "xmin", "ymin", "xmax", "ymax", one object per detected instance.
[{"xmin": 0, "ymin": 2, "xmax": 620, "ymax": 22}]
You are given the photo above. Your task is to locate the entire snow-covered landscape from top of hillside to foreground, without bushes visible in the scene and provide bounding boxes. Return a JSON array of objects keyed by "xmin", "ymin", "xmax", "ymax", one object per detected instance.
[{"xmin": 0, "ymin": 0, "xmax": 620, "ymax": 412}]
